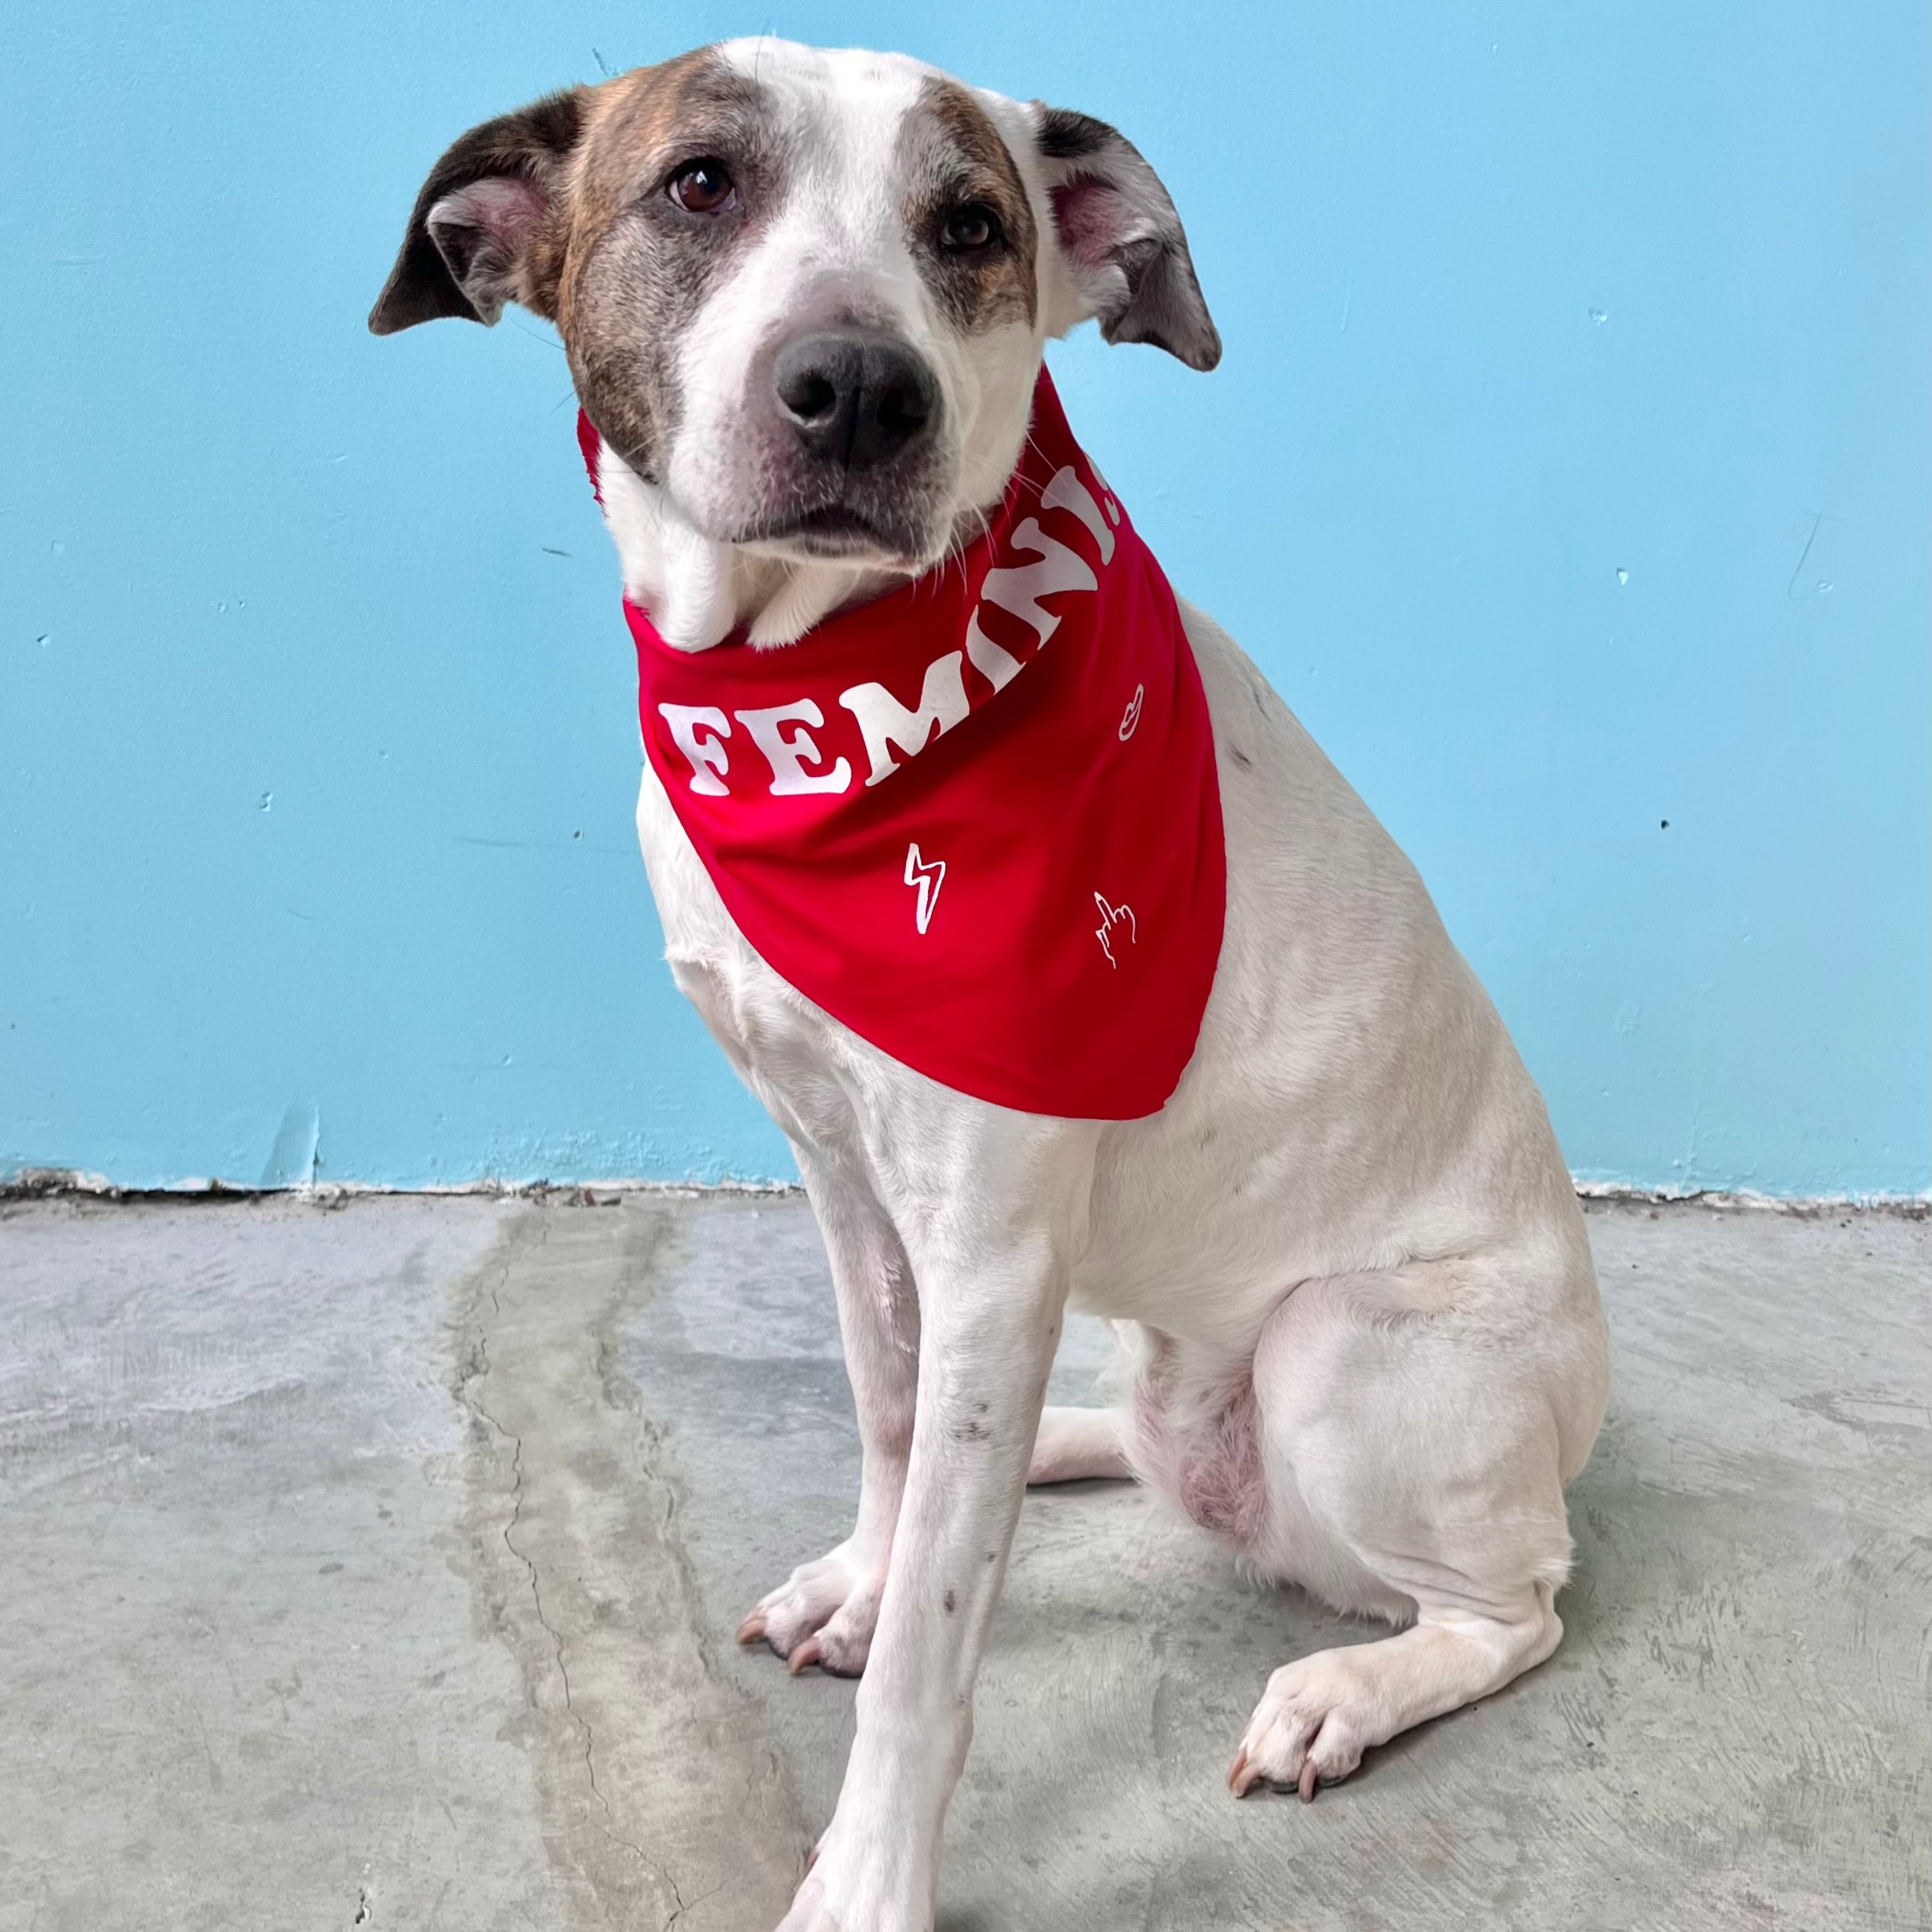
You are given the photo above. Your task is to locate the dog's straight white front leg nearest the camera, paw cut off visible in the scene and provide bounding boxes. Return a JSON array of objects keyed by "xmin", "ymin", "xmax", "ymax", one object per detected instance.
[{"xmin": 781, "ymin": 1107, "xmax": 1097, "ymax": 1932}]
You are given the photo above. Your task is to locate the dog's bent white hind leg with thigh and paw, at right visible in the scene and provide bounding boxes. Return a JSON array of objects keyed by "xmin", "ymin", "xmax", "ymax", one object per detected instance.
[{"xmin": 1229, "ymin": 1231, "xmax": 1604, "ymax": 1799}]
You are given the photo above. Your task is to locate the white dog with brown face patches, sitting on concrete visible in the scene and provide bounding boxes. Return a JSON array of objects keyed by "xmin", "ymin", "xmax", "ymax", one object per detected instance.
[{"xmin": 369, "ymin": 38, "xmax": 1607, "ymax": 1932}]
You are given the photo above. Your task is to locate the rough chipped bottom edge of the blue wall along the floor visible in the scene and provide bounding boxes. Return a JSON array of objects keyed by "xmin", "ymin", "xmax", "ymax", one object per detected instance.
[{"xmin": 0, "ymin": 1167, "xmax": 1932, "ymax": 1221}]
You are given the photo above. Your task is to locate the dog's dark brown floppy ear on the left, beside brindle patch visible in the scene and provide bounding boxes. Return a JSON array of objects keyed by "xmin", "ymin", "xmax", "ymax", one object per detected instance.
[{"xmin": 369, "ymin": 87, "xmax": 583, "ymax": 336}]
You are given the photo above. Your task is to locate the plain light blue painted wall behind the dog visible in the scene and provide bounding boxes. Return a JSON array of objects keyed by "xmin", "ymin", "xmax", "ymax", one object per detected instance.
[{"xmin": 0, "ymin": 0, "xmax": 1932, "ymax": 1194}]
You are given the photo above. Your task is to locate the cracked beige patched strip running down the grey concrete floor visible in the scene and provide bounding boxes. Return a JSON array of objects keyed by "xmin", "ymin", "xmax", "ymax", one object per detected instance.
[{"xmin": 452, "ymin": 1208, "xmax": 796, "ymax": 1932}]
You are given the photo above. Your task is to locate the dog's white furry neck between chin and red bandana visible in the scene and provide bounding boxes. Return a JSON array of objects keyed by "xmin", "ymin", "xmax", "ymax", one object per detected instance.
[{"xmin": 597, "ymin": 444, "xmax": 946, "ymax": 651}]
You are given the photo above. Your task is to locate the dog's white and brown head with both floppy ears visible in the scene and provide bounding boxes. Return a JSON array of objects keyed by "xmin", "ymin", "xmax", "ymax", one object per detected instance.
[{"xmin": 369, "ymin": 41, "xmax": 1221, "ymax": 633}]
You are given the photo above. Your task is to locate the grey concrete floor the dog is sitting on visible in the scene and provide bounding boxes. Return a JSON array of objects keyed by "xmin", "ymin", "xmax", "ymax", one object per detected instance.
[{"xmin": 0, "ymin": 1194, "xmax": 1932, "ymax": 1932}]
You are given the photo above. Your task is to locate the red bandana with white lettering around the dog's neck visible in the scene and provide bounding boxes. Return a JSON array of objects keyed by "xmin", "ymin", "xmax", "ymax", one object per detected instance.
[{"xmin": 578, "ymin": 371, "xmax": 1227, "ymax": 1120}]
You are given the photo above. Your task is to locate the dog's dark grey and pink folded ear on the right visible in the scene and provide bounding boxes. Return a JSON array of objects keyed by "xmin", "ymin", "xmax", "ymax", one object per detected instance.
[{"xmin": 1032, "ymin": 101, "xmax": 1221, "ymax": 369}]
